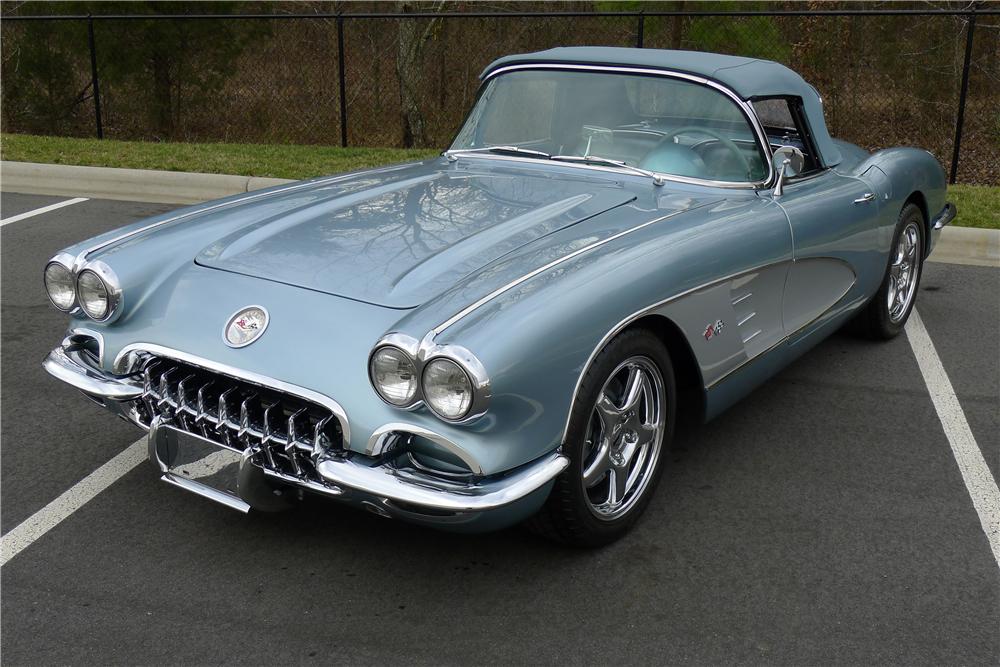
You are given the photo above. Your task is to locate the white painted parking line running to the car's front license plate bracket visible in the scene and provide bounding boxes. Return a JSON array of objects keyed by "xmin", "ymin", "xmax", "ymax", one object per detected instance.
[{"xmin": 0, "ymin": 437, "xmax": 147, "ymax": 566}]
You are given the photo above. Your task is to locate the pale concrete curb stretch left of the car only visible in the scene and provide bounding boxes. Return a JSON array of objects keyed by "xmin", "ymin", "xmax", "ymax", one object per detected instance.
[{"xmin": 0, "ymin": 161, "xmax": 291, "ymax": 204}]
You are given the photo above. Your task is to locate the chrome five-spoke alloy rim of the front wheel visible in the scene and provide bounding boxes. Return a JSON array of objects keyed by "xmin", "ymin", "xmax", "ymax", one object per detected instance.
[{"xmin": 582, "ymin": 356, "xmax": 666, "ymax": 521}]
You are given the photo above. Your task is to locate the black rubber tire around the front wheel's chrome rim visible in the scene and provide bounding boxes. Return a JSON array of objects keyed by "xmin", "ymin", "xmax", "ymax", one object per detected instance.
[{"xmin": 526, "ymin": 329, "xmax": 677, "ymax": 547}]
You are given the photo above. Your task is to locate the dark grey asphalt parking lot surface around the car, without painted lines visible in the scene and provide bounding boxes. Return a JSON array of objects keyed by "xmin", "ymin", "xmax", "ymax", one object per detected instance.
[{"xmin": 0, "ymin": 193, "xmax": 1000, "ymax": 665}]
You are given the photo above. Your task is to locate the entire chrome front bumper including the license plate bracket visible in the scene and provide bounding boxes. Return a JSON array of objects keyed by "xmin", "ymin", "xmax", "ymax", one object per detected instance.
[{"xmin": 42, "ymin": 344, "xmax": 569, "ymax": 523}]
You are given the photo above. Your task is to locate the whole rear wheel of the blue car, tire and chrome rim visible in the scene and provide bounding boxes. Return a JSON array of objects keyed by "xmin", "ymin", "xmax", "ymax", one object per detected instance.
[{"xmin": 858, "ymin": 204, "xmax": 924, "ymax": 340}]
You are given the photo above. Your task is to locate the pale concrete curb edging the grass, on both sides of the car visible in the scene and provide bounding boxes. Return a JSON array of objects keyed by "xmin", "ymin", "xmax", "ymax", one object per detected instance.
[{"xmin": 0, "ymin": 162, "xmax": 1000, "ymax": 267}]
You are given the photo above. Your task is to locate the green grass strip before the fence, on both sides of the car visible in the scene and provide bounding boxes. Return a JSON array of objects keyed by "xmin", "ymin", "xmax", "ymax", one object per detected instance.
[{"xmin": 0, "ymin": 134, "xmax": 1000, "ymax": 229}]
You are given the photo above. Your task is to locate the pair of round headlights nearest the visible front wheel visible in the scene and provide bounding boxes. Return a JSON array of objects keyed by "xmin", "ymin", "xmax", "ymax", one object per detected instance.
[{"xmin": 368, "ymin": 336, "xmax": 489, "ymax": 422}]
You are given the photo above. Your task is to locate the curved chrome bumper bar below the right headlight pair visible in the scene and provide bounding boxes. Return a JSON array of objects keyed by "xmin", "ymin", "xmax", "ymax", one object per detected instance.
[{"xmin": 316, "ymin": 450, "xmax": 569, "ymax": 512}]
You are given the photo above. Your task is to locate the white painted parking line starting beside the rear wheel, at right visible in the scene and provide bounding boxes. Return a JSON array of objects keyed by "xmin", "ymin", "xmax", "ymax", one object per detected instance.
[{"xmin": 906, "ymin": 308, "xmax": 1000, "ymax": 567}]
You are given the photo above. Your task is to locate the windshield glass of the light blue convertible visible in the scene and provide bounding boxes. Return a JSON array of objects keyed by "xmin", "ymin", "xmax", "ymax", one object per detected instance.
[{"xmin": 450, "ymin": 70, "xmax": 767, "ymax": 183}]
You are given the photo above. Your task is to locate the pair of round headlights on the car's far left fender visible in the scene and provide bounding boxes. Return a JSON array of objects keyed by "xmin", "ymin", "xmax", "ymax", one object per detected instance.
[{"xmin": 45, "ymin": 254, "xmax": 122, "ymax": 322}]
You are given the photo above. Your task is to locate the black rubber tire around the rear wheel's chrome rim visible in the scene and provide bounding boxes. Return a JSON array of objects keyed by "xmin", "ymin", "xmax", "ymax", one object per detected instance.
[{"xmin": 856, "ymin": 204, "xmax": 926, "ymax": 340}]
